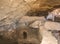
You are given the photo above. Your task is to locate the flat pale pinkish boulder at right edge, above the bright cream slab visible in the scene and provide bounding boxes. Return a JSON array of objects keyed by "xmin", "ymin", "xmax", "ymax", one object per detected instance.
[{"xmin": 44, "ymin": 21, "xmax": 60, "ymax": 30}]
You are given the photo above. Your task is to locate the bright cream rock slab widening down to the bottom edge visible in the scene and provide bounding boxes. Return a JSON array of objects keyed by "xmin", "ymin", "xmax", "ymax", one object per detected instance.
[{"xmin": 40, "ymin": 26, "xmax": 58, "ymax": 44}]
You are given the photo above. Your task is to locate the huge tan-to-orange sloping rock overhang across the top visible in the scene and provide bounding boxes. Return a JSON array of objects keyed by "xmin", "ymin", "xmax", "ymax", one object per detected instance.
[{"xmin": 0, "ymin": 0, "xmax": 60, "ymax": 28}]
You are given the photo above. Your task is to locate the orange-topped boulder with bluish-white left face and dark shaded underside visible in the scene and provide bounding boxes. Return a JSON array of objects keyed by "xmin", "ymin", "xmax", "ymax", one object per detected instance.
[{"xmin": 47, "ymin": 8, "xmax": 60, "ymax": 22}]
